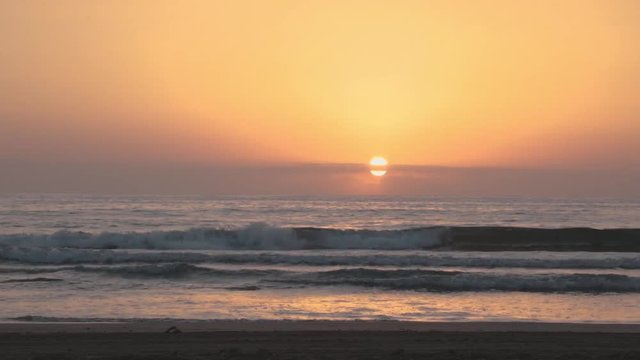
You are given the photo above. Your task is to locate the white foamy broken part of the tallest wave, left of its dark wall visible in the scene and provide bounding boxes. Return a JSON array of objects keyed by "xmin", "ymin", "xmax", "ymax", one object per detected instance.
[{"xmin": 0, "ymin": 223, "xmax": 443, "ymax": 250}]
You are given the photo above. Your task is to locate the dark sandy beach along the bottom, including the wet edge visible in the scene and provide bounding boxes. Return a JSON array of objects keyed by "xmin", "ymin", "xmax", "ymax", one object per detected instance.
[{"xmin": 0, "ymin": 321, "xmax": 640, "ymax": 360}]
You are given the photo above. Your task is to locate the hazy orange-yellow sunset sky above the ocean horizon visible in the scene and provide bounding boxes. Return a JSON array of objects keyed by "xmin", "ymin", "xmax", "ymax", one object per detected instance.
[{"xmin": 0, "ymin": 0, "xmax": 640, "ymax": 195}]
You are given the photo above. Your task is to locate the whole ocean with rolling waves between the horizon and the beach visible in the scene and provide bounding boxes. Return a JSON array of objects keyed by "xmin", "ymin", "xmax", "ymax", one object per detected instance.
[{"xmin": 0, "ymin": 194, "xmax": 640, "ymax": 323}]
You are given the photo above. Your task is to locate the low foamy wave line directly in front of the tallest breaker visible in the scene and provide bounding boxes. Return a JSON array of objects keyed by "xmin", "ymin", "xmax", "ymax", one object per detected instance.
[{"xmin": 0, "ymin": 247, "xmax": 640, "ymax": 268}]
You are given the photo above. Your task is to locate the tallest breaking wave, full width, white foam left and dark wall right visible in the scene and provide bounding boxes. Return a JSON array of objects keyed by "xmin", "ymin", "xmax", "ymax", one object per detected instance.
[{"xmin": 0, "ymin": 223, "xmax": 640, "ymax": 252}]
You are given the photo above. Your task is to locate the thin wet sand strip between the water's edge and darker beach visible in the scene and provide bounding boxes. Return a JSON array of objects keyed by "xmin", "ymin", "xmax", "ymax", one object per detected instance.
[{"xmin": 0, "ymin": 319, "xmax": 640, "ymax": 334}]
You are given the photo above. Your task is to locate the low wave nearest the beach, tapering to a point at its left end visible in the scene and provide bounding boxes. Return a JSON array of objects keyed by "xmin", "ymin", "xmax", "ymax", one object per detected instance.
[{"xmin": 278, "ymin": 268, "xmax": 640, "ymax": 293}]
